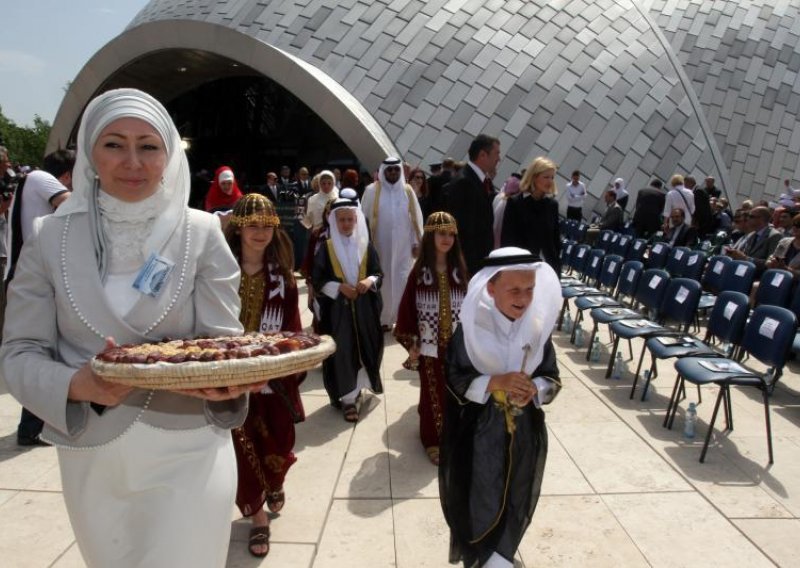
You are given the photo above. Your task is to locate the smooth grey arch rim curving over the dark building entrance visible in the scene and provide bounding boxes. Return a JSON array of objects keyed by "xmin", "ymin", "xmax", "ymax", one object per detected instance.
[{"xmin": 47, "ymin": 20, "xmax": 399, "ymax": 168}]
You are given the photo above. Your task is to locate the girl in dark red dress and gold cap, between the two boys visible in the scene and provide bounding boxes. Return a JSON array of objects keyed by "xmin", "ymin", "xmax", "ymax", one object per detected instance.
[{"xmin": 394, "ymin": 211, "xmax": 467, "ymax": 465}]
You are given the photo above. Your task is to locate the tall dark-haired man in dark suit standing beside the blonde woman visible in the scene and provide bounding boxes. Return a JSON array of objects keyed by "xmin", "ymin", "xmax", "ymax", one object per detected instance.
[{"xmin": 444, "ymin": 134, "xmax": 500, "ymax": 274}]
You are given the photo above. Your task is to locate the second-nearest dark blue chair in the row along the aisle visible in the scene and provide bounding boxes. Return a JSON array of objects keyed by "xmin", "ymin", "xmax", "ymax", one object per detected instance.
[{"xmin": 644, "ymin": 292, "xmax": 750, "ymax": 404}]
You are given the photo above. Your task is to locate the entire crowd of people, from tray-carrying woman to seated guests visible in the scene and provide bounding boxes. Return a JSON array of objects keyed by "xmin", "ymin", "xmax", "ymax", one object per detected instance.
[{"xmin": 0, "ymin": 85, "xmax": 800, "ymax": 567}]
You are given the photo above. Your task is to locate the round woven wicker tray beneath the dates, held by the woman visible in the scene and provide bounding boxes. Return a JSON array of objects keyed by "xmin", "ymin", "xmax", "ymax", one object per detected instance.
[{"xmin": 91, "ymin": 335, "xmax": 336, "ymax": 390}]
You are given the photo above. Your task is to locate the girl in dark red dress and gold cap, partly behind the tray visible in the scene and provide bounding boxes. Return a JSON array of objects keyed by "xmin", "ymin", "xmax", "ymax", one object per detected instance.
[{"xmin": 225, "ymin": 193, "xmax": 305, "ymax": 557}]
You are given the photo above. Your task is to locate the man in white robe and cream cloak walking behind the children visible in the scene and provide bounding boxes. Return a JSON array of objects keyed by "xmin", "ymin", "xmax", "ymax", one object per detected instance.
[{"xmin": 361, "ymin": 157, "xmax": 423, "ymax": 331}]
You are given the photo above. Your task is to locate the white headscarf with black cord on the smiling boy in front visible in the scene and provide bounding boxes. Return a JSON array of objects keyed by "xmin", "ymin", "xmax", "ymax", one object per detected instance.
[{"xmin": 460, "ymin": 247, "xmax": 561, "ymax": 375}]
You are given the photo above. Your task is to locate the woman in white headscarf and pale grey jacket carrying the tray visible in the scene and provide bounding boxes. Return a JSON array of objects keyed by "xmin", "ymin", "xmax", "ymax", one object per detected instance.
[{"xmin": 0, "ymin": 89, "xmax": 255, "ymax": 567}]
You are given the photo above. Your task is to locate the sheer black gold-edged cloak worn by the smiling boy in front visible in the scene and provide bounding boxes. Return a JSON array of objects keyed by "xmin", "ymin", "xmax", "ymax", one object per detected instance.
[{"xmin": 439, "ymin": 327, "xmax": 560, "ymax": 568}]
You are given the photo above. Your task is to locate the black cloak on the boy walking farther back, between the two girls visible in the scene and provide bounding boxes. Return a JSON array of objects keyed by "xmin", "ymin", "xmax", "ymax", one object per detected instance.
[{"xmin": 312, "ymin": 243, "xmax": 383, "ymax": 408}]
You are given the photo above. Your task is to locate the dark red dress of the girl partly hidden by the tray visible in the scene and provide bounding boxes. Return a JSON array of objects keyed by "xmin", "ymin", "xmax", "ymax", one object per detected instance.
[{"xmin": 233, "ymin": 264, "xmax": 305, "ymax": 516}]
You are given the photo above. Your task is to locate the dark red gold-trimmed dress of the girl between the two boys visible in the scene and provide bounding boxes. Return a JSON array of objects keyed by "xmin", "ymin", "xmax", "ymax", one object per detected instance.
[{"xmin": 394, "ymin": 267, "xmax": 467, "ymax": 449}]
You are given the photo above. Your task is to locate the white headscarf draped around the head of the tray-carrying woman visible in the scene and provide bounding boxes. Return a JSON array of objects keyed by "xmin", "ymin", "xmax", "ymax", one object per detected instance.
[{"xmin": 54, "ymin": 89, "xmax": 190, "ymax": 281}]
